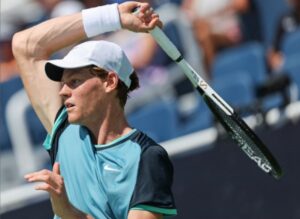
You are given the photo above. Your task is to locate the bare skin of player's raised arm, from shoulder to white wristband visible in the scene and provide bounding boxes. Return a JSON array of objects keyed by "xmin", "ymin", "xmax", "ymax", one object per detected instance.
[{"xmin": 13, "ymin": 13, "xmax": 85, "ymax": 132}]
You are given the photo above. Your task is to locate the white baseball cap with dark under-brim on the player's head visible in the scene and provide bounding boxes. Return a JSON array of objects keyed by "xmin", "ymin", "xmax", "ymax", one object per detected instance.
[{"xmin": 45, "ymin": 41, "xmax": 134, "ymax": 87}]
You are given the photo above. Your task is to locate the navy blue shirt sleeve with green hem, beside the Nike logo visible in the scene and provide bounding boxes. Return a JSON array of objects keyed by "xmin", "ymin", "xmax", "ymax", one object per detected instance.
[{"xmin": 130, "ymin": 145, "xmax": 177, "ymax": 215}]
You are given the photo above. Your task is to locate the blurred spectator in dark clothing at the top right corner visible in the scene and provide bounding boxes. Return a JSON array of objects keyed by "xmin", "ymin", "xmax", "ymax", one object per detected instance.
[{"xmin": 268, "ymin": 0, "xmax": 300, "ymax": 71}]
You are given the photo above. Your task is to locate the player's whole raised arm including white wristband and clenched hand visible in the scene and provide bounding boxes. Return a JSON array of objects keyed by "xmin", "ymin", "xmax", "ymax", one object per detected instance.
[{"xmin": 13, "ymin": 2, "xmax": 161, "ymax": 132}]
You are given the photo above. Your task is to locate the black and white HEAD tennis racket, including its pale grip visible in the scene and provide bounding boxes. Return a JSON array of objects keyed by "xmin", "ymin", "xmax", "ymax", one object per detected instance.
[{"xmin": 149, "ymin": 27, "xmax": 282, "ymax": 179}]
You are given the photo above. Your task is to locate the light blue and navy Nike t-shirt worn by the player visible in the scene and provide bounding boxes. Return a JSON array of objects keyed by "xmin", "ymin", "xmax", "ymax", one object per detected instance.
[{"xmin": 44, "ymin": 109, "xmax": 177, "ymax": 219}]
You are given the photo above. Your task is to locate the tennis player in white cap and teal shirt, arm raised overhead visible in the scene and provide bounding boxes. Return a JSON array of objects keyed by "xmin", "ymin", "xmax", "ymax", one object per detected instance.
[{"xmin": 13, "ymin": 2, "xmax": 176, "ymax": 219}]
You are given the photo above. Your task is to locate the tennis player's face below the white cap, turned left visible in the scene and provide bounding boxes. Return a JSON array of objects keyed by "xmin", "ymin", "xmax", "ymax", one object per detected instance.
[{"xmin": 59, "ymin": 67, "xmax": 109, "ymax": 126}]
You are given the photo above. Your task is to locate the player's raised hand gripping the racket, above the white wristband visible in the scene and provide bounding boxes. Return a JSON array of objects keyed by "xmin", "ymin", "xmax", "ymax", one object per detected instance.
[{"xmin": 118, "ymin": 2, "xmax": 162, "ymax": 32}]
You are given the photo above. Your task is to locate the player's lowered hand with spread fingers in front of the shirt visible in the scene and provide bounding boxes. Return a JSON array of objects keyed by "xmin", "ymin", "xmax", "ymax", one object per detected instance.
[{"xmin": 24, "ymin": 163, "xmax": 72, "ymax": 218}]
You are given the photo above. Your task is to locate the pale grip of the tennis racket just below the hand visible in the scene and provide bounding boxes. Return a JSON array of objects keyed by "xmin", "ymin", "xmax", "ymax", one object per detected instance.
[{"xmin": 149, "ymin": 26, "xmax": 182, "ymax": 62}]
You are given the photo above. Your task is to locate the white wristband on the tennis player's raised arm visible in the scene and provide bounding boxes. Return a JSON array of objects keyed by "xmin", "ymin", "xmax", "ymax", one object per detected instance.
[{"xmin": 81, "ymin": 4, "xmax": 121, "ymax": 37}]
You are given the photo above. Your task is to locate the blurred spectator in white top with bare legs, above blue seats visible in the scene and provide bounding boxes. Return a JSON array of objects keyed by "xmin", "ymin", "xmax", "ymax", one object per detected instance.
[{"xmin": 184, "ymin": 0, "xmax": 249, "ymax": 76}]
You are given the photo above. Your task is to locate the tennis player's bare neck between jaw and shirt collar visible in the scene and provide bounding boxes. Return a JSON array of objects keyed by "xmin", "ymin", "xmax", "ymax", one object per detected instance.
[{"xmin": 87, "ymin": 105, "xmax": 132, "ymax": 144}]
